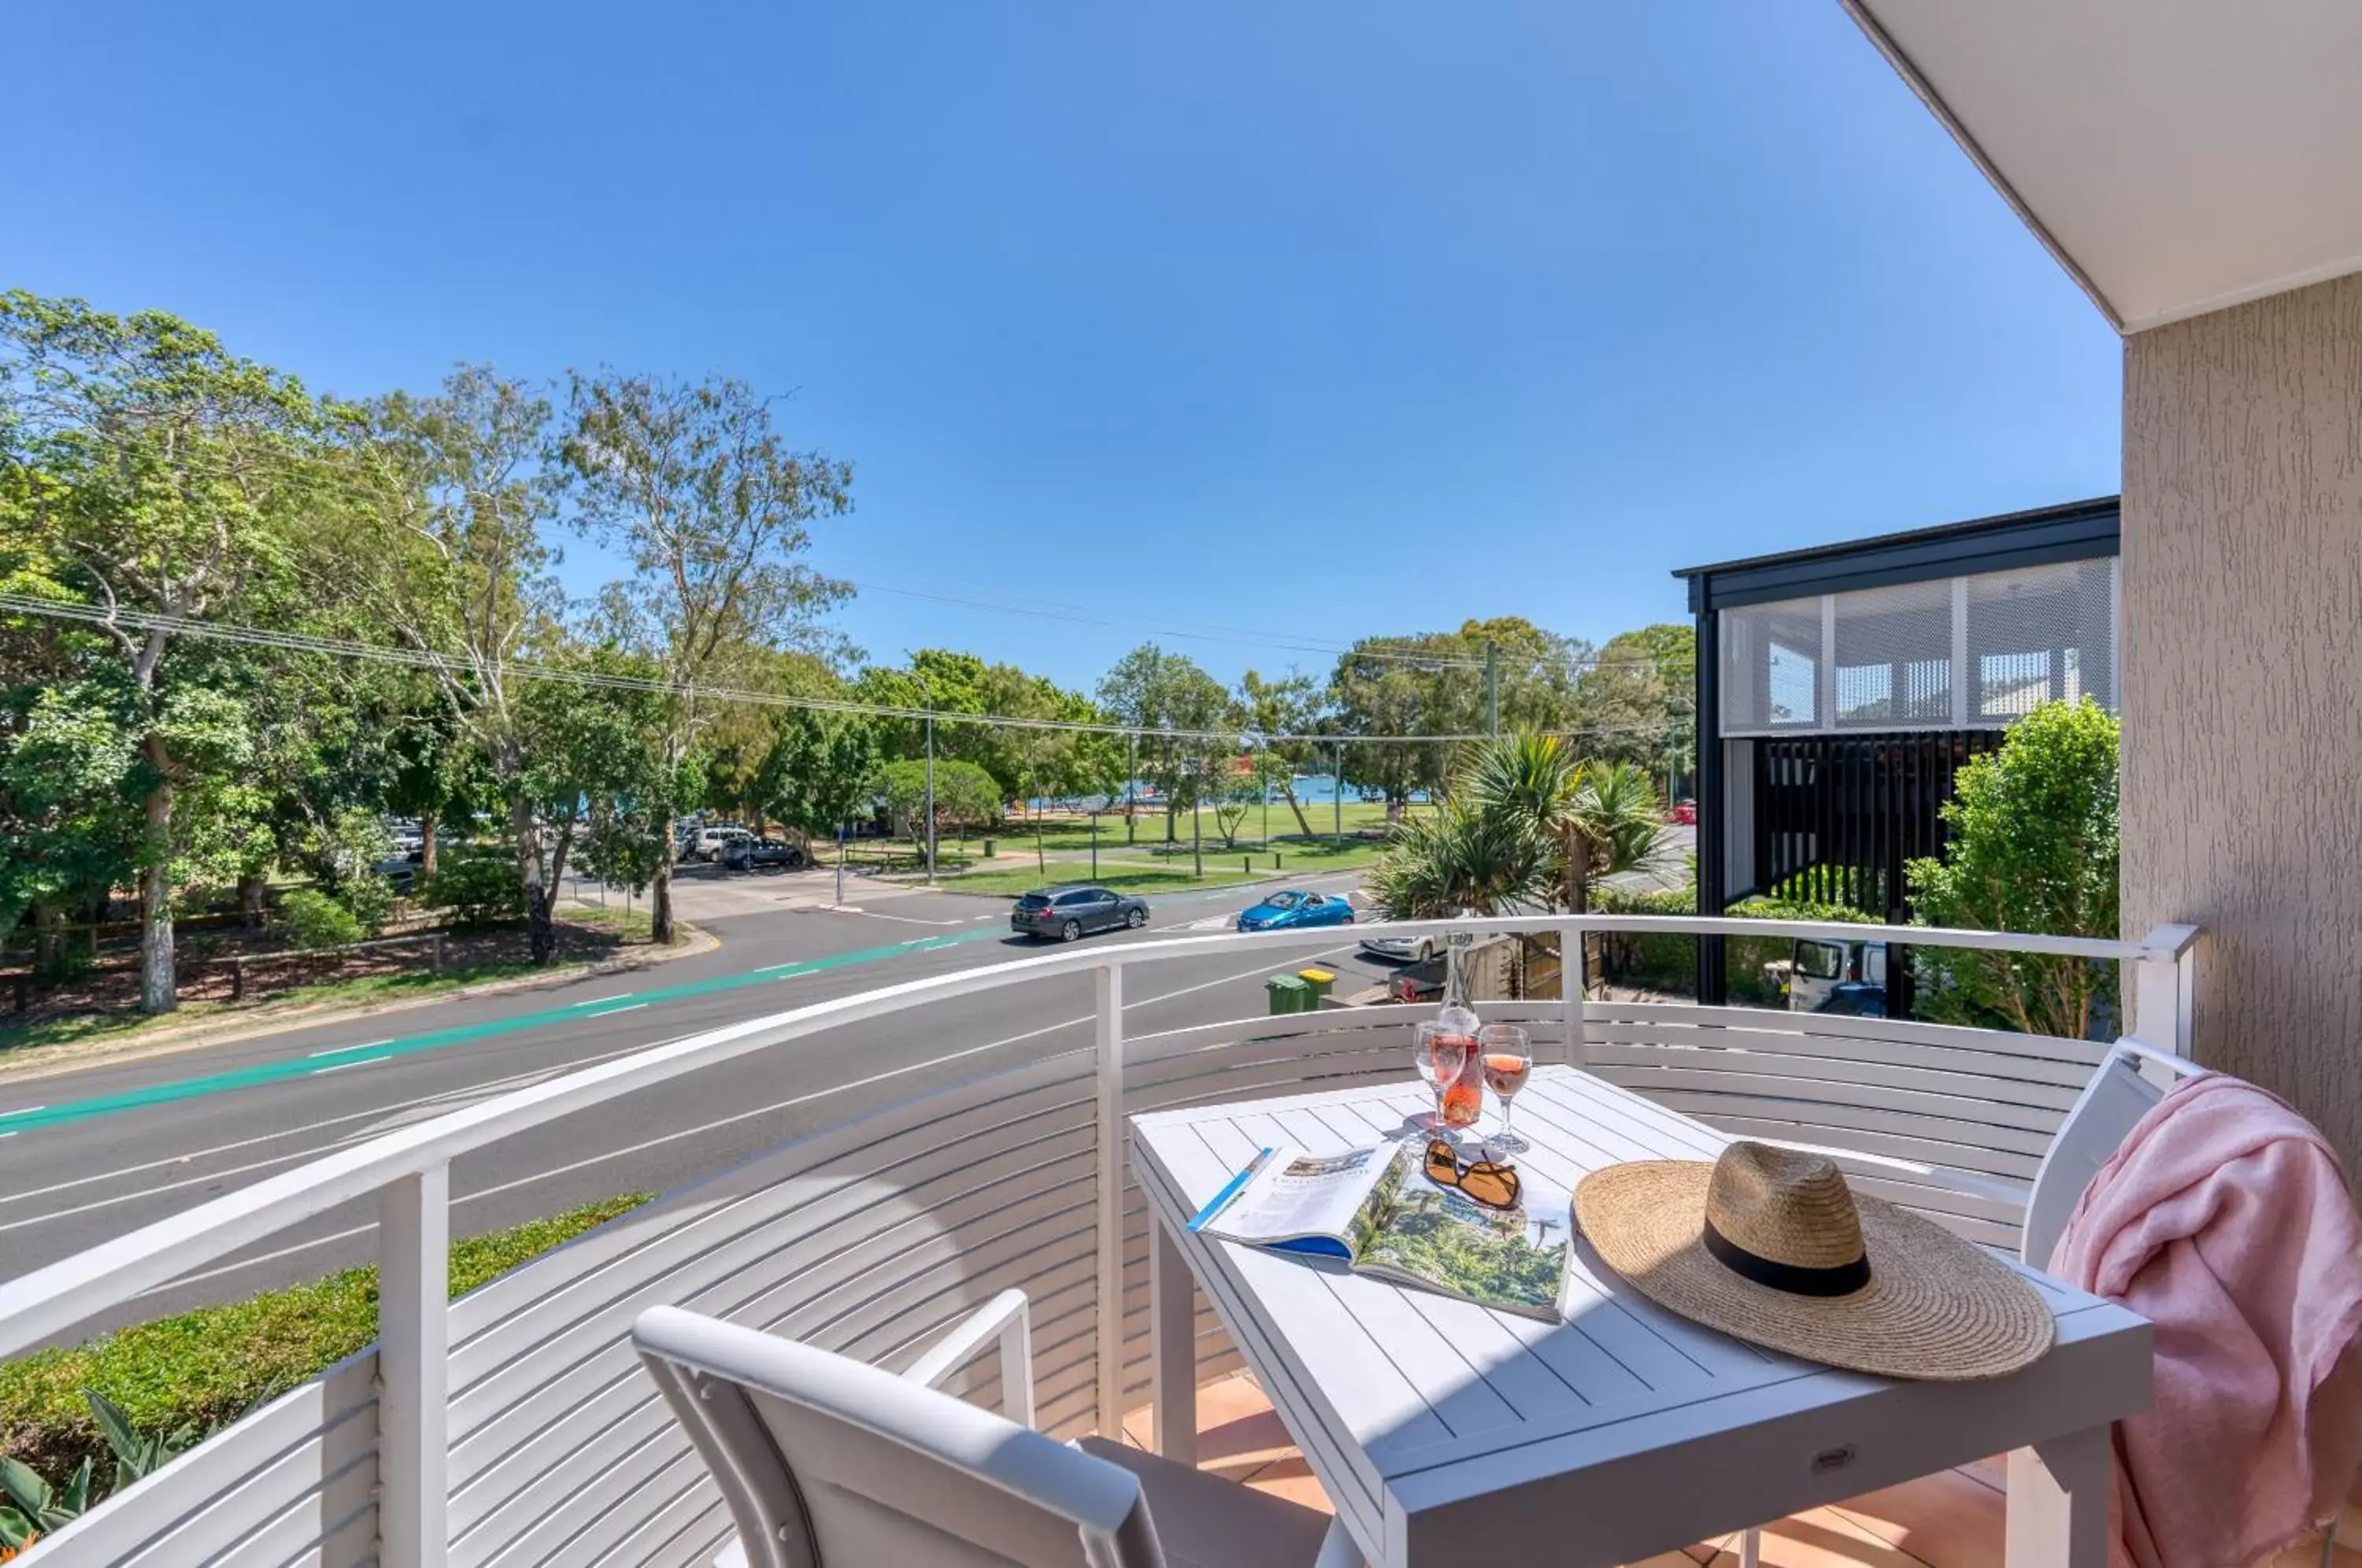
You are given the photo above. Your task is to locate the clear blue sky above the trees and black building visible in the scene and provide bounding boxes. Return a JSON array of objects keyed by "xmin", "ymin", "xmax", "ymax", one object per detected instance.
[{"xmin": 0, "ymin": 0, "xmax": 2119, "ymax": 685}]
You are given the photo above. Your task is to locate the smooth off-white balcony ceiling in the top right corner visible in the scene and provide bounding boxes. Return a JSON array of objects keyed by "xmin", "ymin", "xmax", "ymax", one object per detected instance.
[{"xmin": 1840, "ymin": 0, "xmax": 2362, "ymax": 333}]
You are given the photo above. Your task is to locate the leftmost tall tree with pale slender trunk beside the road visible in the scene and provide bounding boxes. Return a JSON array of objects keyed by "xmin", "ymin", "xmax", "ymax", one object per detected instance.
[{"xmin": 0, "ymin": 290, "xmax": 331, "ymax": 1013}]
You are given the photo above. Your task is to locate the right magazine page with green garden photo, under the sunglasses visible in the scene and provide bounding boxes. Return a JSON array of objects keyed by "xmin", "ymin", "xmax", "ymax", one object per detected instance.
[{"xmin": 1353, "ymin": 1145, "xmax": 1573, "ymax": 1322}]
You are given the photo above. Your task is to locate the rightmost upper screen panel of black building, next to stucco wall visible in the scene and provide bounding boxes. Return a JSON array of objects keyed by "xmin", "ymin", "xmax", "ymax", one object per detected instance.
[{"xmin": 1968, "ymin": 560, "xmax": 2116, "ymax": 725}]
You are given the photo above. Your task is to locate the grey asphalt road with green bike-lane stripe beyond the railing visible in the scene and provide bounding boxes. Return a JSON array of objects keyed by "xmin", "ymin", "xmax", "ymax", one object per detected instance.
[{"xmin": 0, "ymin": 874, "xmax": 1386, "ymax": 1337}]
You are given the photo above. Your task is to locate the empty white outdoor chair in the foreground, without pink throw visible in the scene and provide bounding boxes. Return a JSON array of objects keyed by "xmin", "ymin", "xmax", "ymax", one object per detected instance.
[{"xmin": 631, "ymin": 1292, "xmax": 1361, "ymax": 1568}]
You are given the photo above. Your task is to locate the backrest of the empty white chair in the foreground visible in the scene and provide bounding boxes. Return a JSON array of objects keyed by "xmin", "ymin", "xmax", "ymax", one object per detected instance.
[{"xmin": 631, "ymin": 1306, "xmax": 1164, "ymax": 1568}]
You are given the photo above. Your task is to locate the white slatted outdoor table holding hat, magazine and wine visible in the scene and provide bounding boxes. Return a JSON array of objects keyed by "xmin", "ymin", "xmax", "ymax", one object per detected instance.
[{"xmin": 1131, "ymin": 1067, "xmax": 2149, "ymax": 1568}]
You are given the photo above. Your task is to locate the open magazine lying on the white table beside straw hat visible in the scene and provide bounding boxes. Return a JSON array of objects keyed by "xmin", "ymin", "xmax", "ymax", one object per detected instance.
[{"xmin": 1188, "ymin": 1138, "xmax": 1573, "ymax": 1322}]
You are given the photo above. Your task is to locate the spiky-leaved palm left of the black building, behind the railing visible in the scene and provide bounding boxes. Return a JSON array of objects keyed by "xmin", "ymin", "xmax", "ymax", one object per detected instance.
[{"xmin": 1460, "ymin": 734, "xmax": 1665, "ymax": 914}]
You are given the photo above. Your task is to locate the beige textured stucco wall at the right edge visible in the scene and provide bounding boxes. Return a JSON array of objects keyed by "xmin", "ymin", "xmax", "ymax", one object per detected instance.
[{"xmin": 2123, "ymin": 276, "xmax": 2362, "ymax": 1178}]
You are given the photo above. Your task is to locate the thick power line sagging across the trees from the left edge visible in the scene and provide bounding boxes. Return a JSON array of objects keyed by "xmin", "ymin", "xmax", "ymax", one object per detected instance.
[{"xmin": 0, "ymin": 593, "xmax": 1701, "ymax": 746}]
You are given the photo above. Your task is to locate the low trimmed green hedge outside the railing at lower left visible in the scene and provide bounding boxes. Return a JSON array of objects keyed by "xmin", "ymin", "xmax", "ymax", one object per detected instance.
[{"xmin": 0, "ymin": 1193, "xmax": 650, "ymax": 1485}]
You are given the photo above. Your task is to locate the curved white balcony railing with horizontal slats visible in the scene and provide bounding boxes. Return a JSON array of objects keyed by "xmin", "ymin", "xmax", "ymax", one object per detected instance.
[{"xmin": 0, "ymin": 916, "xmax": 2194, "ymax": 1568}]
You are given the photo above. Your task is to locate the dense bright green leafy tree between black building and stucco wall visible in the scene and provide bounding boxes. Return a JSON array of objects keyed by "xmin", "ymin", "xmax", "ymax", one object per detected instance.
[{"xmin": 1904, "ymin": 697, "xmax": 2119, "ymax": 1039}]
